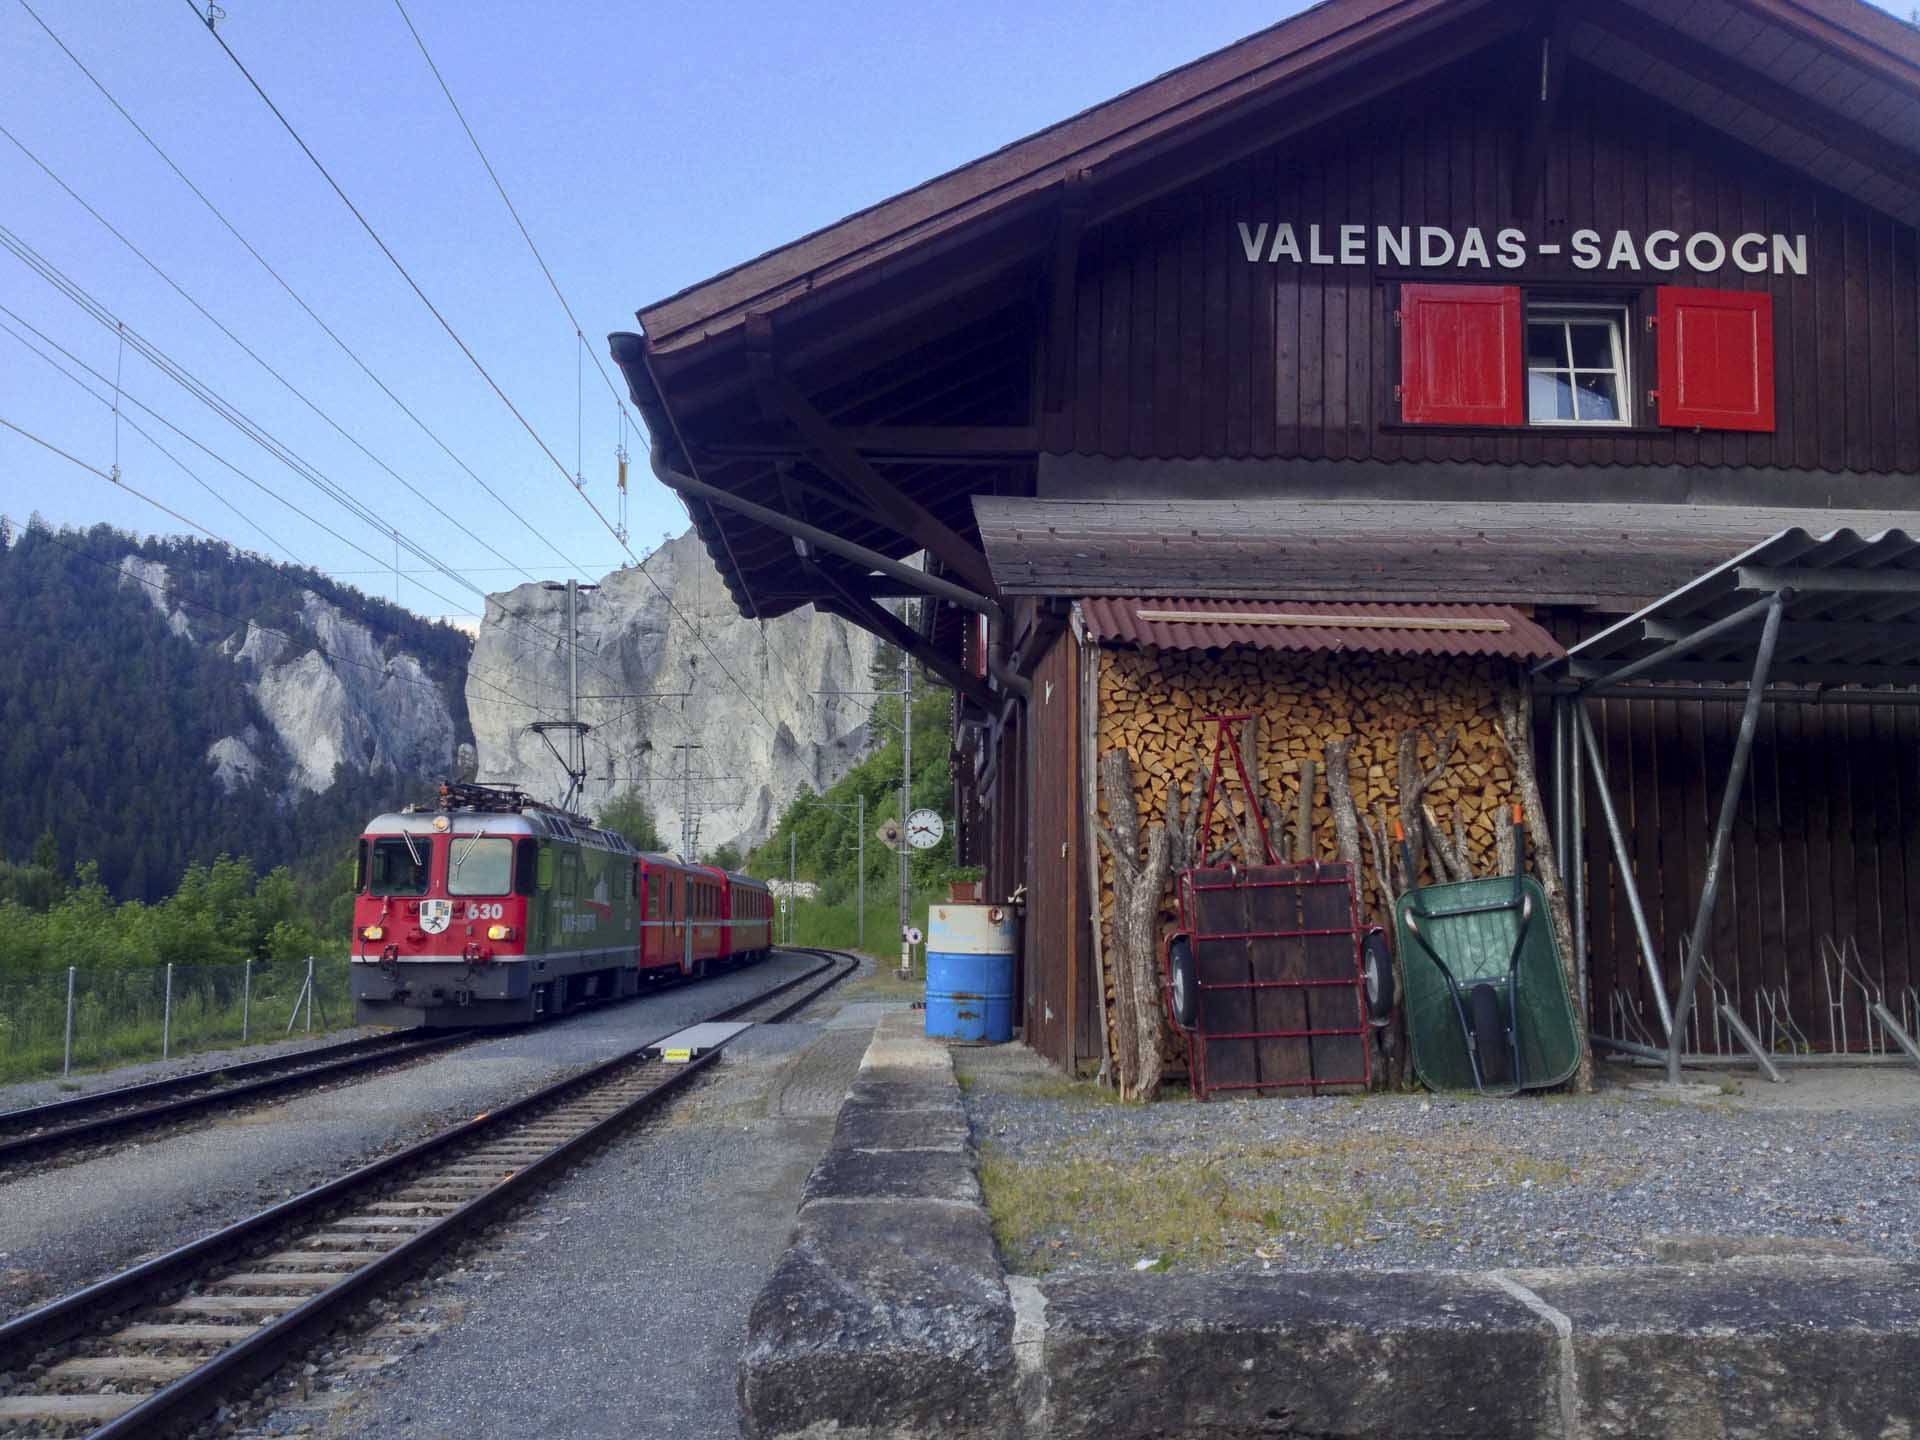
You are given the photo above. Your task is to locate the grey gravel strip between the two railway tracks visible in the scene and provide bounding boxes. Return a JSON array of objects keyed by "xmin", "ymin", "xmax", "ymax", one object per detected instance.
[{"xmin": 0, "ymin": 954, "xmax": 818, "ymax": 1315}]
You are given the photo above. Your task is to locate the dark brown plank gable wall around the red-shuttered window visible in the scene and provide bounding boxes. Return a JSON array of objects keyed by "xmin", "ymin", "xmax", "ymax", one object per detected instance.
[{"xmin": 1046, "ymin": 48, "xmax": 1920, "ymax": 472}]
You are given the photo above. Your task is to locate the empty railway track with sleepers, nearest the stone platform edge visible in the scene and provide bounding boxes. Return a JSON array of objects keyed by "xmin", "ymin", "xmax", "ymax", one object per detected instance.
[{"xmin": 0, "ymin": 947, "xmax": 856, "ymax": 1440}]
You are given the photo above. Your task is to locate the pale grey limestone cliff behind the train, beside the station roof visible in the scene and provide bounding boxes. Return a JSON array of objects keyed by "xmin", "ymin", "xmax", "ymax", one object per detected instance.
[{"xmin": 467, "ymin": 532, "xmax": 877, "ymax": 852}]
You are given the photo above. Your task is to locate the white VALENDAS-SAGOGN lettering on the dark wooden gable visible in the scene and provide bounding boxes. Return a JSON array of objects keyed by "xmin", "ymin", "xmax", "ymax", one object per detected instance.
[{"xmin": 1236, "ymin": 221, "xmax": 1807, "ymax": 275}]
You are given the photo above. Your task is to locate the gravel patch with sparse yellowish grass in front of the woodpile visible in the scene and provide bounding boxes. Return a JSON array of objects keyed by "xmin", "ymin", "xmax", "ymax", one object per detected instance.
[{"xmin": 954, "ymin": 1046, "xmax": 1920, "ymax": 1275}]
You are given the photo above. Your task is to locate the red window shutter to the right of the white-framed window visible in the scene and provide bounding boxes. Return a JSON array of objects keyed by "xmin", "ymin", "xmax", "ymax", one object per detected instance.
[{"xmin": 1659, "ymin": 286, "xmax": 1774, "ymax": 430}]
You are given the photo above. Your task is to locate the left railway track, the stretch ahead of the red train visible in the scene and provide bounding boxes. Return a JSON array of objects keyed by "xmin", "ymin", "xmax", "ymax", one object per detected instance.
[{"xmin": 0, "ymin": 1031, "xmax": 472, "ymax": 1167}]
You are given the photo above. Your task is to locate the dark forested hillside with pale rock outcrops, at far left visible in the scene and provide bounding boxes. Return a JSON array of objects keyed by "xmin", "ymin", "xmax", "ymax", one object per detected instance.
[{"xmin": 0, "ymin": 522, "xmax": 470, "ymax": 900}]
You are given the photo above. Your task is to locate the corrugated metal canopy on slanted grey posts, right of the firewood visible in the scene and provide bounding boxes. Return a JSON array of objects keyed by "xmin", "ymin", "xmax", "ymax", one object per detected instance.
[{"xmin": 1534, "ymin": 516, "xmax": 1920, "ymax": 1081}]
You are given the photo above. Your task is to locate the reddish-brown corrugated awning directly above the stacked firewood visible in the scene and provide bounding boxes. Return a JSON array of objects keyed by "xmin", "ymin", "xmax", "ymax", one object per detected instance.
[{"xmin": 1081, "ymin": 595, "xmax": 1567, "ymax": 660}]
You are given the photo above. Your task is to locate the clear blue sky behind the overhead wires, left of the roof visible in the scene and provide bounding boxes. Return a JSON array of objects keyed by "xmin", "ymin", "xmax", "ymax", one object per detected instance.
[{"xmin": 0, "ymin": 0, "xmax": 1300, "ymax": 614}]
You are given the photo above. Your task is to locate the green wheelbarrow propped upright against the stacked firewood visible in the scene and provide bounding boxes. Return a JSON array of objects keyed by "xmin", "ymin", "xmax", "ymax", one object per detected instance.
[{"xmin": 1394, "ymin": 826, "xmax": 1580, "ymax": 1094}]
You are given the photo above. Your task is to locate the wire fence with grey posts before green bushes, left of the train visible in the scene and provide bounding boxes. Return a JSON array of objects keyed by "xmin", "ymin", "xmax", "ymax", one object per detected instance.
[{"xmin": 0, "ymin": 958, "xmax": 353, "ymax": 1081}]
